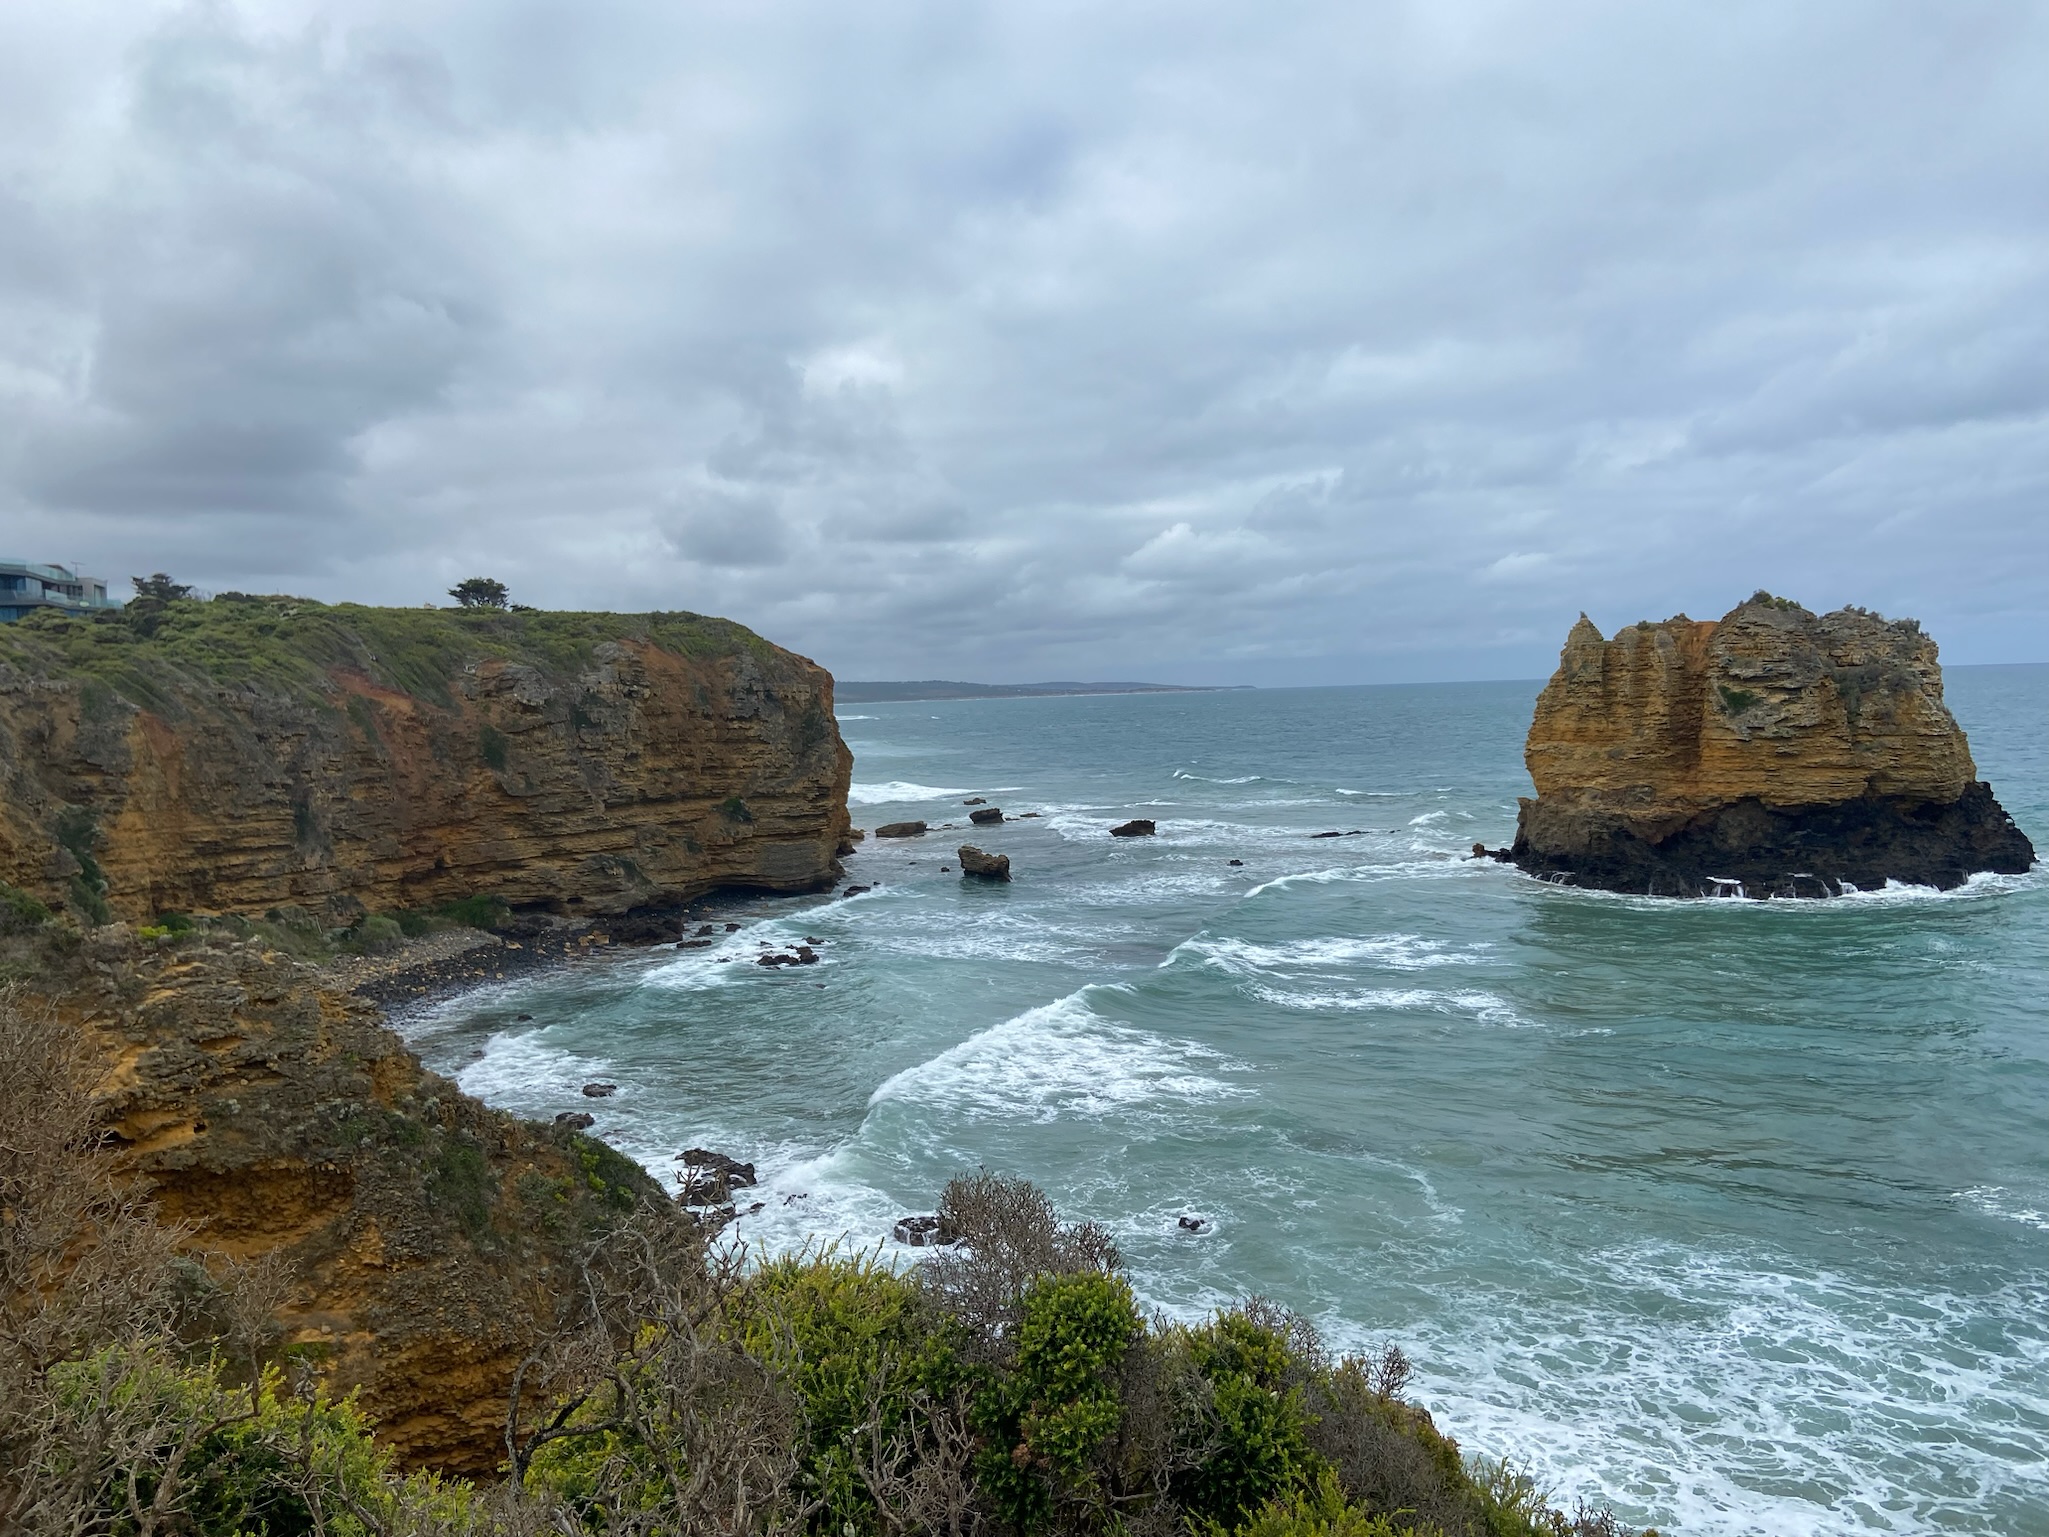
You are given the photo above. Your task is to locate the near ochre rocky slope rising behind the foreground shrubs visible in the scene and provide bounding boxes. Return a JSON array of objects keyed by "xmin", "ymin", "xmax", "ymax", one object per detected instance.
[{"xmin": 39, "ymin": 924, "xmax": 660, "ymax": 1473}]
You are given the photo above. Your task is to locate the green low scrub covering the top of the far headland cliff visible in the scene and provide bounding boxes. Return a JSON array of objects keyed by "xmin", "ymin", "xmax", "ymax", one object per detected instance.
[{"xmin": 0, "ymin": 592, "xmax": 775, "ymax": 711}]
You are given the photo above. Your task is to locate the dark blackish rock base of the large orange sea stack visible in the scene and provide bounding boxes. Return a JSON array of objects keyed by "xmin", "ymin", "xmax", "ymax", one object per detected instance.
[{"xmin": 1508, "ymin": 783, "xmax": 2035, "ymax": 898}]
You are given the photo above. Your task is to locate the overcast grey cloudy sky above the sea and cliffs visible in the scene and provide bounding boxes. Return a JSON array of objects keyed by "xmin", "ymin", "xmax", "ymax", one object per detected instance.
[{"xmin": 0, "ymin": 0, "xmax": 2049, "ymax": 684}]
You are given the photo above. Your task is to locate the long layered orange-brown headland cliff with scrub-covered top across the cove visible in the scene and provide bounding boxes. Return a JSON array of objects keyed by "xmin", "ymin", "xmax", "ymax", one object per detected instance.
[{"xmin": 0, "ymin": 598, "xmax": 852, "ymax": 922}]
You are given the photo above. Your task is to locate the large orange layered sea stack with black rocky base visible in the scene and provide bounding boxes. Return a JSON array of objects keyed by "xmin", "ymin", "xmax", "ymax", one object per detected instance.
[{"xmin": 1510, "ymin": 592, "xmax": 2035, "ymax": 898}]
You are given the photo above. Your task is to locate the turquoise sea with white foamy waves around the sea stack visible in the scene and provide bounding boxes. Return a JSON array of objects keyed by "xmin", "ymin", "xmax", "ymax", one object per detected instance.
[{"xmin": 406, "ymin": 666, "xmax": 2049, "ymax": 1533}]
